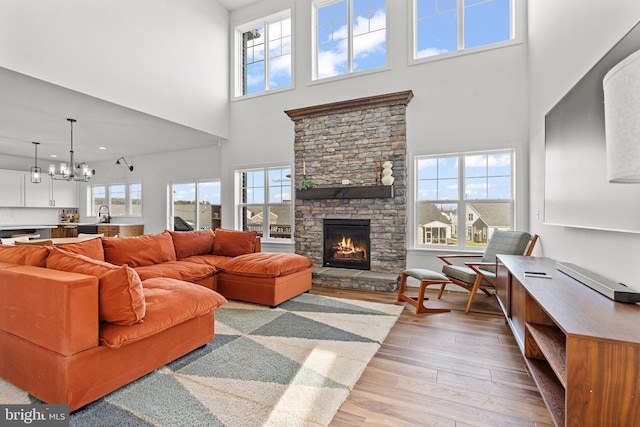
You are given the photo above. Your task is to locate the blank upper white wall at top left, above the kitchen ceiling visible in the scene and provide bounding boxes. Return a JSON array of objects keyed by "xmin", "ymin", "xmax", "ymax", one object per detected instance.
[{"xmin": 0, "ymin": 0, "xmax": 229, "ymax": 137}]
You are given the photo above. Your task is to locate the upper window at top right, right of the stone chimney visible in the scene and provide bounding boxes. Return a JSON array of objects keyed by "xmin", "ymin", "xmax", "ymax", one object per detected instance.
[{"xmin": 414, "ymin": 0, "xmax": 515, "ymax": 59}]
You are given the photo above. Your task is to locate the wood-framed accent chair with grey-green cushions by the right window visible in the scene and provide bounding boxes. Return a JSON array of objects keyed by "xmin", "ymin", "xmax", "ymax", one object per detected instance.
[{"xmin": 438, "ymin": 230, "xmax": 538, "ymax": 313}]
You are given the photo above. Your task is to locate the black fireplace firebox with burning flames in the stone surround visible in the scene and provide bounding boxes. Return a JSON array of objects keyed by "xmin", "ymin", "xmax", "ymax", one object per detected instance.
[{"xmin": 322, "ymin": 219, "xmax": 371, "ymax": 270}]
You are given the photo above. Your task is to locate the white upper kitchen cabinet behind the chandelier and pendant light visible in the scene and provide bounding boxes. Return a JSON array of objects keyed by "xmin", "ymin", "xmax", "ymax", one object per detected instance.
[{"xmin": 25, "ymin": 174, "xmax": 78, "ymax": 208}]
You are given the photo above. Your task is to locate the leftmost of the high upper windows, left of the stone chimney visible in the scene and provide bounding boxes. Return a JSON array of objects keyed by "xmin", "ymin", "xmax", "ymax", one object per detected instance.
[{"xmin": 235, "ymin": 10, "xmax": 293, "ymax": 96}]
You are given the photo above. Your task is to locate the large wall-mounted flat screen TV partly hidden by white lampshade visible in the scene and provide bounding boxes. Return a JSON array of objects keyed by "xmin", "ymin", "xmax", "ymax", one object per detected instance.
[{"xmin": 544, "ymin": 23, "xmax": 640, "ymax": 233}]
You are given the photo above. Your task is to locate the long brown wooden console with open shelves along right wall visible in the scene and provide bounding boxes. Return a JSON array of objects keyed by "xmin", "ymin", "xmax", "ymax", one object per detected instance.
[{"xmin": 496, "ymin": 255, "xmax": 640, "ymax": 427}]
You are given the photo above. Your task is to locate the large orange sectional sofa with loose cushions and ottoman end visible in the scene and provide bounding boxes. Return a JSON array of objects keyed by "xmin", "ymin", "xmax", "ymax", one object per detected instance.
[{"xmin": 0, "ymin": 230, "xmax": 311, "ymax": 411}]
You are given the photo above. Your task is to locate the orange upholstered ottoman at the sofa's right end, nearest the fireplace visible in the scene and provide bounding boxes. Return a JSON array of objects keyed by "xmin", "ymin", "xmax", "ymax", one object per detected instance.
[{"xmin": 217, "ymin": 252, "xmax": 312, "ymax": 307}]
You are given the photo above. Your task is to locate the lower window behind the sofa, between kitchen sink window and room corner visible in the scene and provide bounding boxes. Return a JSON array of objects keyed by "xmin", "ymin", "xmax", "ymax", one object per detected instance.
[{"xmin": 167, "ymin": 180, "xmax": 221, "ymax": 231}]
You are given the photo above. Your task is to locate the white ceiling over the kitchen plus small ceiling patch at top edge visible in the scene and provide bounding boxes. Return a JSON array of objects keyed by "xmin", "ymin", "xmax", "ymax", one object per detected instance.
[{"xmin": 0, "ymin": 0, "xmax": 259, "ymax": 168}]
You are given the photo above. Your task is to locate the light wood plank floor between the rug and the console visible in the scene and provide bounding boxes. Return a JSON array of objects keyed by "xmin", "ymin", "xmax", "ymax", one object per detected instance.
[{"xmin": 311, "ymin": 286, "xmax": 553, "ymax": 427}]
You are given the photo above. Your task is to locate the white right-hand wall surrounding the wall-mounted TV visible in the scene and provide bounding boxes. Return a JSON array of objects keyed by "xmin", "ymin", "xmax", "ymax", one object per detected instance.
[{"xmin": 528, "ymin": 0, "xmax": 640, "ymax": 290}]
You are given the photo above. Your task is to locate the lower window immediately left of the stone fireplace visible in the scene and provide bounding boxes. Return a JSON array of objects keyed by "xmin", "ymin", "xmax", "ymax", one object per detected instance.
[{"xmin": 236, "ymin": 166, "xmax": 293, "ymax": 240}]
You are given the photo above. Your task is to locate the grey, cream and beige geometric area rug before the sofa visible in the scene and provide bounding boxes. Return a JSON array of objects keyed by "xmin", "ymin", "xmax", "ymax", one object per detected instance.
[{"xmin": 0, "ymin": 294, "xmax": 404, "ymax": 427}]
